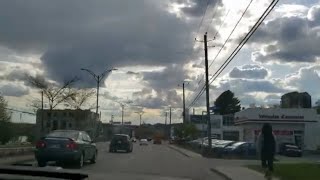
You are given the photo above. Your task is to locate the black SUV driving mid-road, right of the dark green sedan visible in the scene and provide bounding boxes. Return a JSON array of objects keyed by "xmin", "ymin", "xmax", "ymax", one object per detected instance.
[{"xmin": 109, "ymin": 134, "xmax": 133, "ymax": 152}]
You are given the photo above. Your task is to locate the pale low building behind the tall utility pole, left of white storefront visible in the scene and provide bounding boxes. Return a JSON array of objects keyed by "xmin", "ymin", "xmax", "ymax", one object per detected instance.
[{"xmin": 190, "ymin": 114, "xmax": 243, "ymax": 141}]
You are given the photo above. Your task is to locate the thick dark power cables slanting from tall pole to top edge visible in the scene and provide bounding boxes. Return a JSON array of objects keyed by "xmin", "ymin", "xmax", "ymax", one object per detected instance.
[{"xmin": 188, "ymin": 0, "xmax": 279, "ymax": 108}]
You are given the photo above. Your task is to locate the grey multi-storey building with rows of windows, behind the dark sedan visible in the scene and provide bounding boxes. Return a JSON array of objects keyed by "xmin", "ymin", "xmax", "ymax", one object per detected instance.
[{"xmin": 36, "ymin": 109, "xmax": 101, "ymax": 138}]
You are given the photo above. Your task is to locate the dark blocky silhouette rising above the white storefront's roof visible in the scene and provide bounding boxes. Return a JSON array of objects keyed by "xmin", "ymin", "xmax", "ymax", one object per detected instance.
[{"xmin": 281, "ymin": 92, "xmax": 311, "ymax": 108}]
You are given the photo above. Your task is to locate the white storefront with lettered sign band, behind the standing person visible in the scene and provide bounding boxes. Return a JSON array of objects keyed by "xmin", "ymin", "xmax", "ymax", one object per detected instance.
[{"xmin": 234, "ymin": 108, "xmax": 320, "ymax": 150}]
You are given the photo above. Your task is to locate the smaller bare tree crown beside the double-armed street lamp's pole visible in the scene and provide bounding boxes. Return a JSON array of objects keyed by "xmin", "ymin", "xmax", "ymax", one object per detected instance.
[{"xmin": 66, "ymin": 89, "xmax": 95, "ymax": 109}]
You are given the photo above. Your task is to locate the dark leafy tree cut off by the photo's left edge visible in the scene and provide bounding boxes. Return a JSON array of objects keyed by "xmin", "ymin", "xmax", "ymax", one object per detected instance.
[{"xmin": 0, "ymin": 95, "xmax": 14, "ymax": 144}]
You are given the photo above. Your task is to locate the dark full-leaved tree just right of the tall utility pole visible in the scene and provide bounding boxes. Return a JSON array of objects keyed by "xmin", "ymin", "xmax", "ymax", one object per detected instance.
[{"xmin": 214, "ymin": 90, "xmax": 241, "ymax": 115}]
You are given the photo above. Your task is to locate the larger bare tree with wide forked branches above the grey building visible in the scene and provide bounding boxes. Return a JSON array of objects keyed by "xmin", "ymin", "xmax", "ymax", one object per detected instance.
[{"xmin": 28, "ymin": 76, "xmax": 78, "ymax": 110}]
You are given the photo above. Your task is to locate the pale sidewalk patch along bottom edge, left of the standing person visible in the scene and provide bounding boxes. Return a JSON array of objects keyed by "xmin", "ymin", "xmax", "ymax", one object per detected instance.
[{"xmin": 211, "ymin": 166, "xmax": 278, "ymax": 180}]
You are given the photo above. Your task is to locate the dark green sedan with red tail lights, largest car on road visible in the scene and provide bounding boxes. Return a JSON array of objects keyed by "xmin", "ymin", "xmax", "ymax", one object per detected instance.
[{"xmin": 35, "ymin": 130, "xmax": 98, "ymax": 168}]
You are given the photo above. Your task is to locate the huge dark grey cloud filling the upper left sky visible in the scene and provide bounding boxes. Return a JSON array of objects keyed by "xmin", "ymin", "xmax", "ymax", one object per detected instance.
[{"xmin": 0, "ymin": 0, "xmax": 208, "ymax": 85}]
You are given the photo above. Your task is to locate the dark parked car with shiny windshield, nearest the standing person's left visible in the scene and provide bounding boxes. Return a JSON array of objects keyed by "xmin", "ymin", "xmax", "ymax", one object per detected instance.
[{"xmin": 223, "ymin": 141, "xmax": 257, "ymax": 158}]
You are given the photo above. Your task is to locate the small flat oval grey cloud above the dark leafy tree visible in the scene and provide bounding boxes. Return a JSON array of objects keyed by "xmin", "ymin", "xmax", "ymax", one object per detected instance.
[{"xmin": 229, "ymin": 64, "xmax": 268, "ymax": 79}]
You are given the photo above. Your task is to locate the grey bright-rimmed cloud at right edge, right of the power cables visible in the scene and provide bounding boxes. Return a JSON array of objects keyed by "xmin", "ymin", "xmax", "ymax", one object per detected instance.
[{"xmin": 250, "ymin": 5, "xmax": 320, "ymax": 62}]
